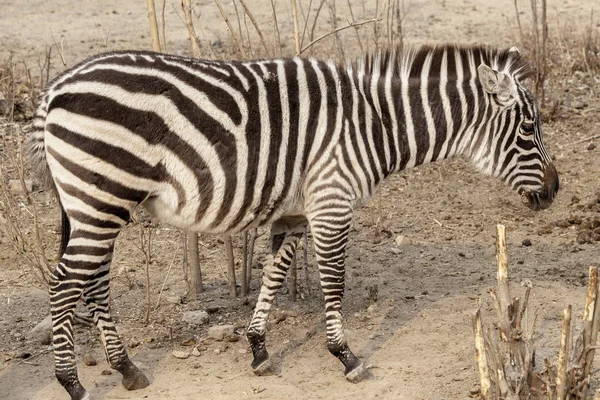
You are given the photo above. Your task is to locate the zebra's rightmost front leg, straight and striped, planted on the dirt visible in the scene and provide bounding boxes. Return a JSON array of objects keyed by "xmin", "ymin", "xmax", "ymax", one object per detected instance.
[{"xmin": 311, "ymin": 210, "xmax": 365, "ymax": 382}]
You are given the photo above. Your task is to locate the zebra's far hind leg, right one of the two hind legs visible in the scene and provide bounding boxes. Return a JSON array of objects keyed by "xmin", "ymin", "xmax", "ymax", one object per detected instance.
[{"xmin": 83, "ymin": 251, "xmax": 150, "ymax": 390}]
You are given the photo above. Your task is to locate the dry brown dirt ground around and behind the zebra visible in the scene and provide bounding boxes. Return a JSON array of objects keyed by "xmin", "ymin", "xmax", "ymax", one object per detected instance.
[{"xmin": 0, "ymin": 0, "xmax": 600, "ymax": 400}]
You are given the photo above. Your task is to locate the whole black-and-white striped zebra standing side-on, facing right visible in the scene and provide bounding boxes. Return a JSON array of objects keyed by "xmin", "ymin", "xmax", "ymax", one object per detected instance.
[{"xmin": 27, "ymin": 44, "xmax": 559, "ymax": 399}]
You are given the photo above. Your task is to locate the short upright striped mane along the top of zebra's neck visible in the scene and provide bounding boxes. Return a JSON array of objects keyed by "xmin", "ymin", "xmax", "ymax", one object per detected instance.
[{"xmin": 350, "ymin": 44, "xmax": 534, "ymax": 81}]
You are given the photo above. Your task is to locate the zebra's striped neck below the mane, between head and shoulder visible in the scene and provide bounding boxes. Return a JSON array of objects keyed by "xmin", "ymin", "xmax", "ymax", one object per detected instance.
[{"xmin": 355, "ymin": 75, "xmax": 490, "ymax": 183}]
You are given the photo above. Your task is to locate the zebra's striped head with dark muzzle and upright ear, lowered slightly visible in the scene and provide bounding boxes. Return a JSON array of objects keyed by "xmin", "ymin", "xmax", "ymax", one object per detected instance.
[{"xmin": 471, "ymin": 47, "xmax": 559, "ymax": 211}]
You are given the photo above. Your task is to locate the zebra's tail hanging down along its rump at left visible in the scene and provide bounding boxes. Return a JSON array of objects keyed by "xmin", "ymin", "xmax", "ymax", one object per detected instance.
[{"xmin": 25, "ymin": 93, "xmax": 71, "ymax": 259}]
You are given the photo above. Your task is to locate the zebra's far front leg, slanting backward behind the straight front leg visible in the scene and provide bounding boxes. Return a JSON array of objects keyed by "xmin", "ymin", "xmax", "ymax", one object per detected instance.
[{"xmin": 246, "ymin": 219, "xmax": 306, "ymax": 375}]
